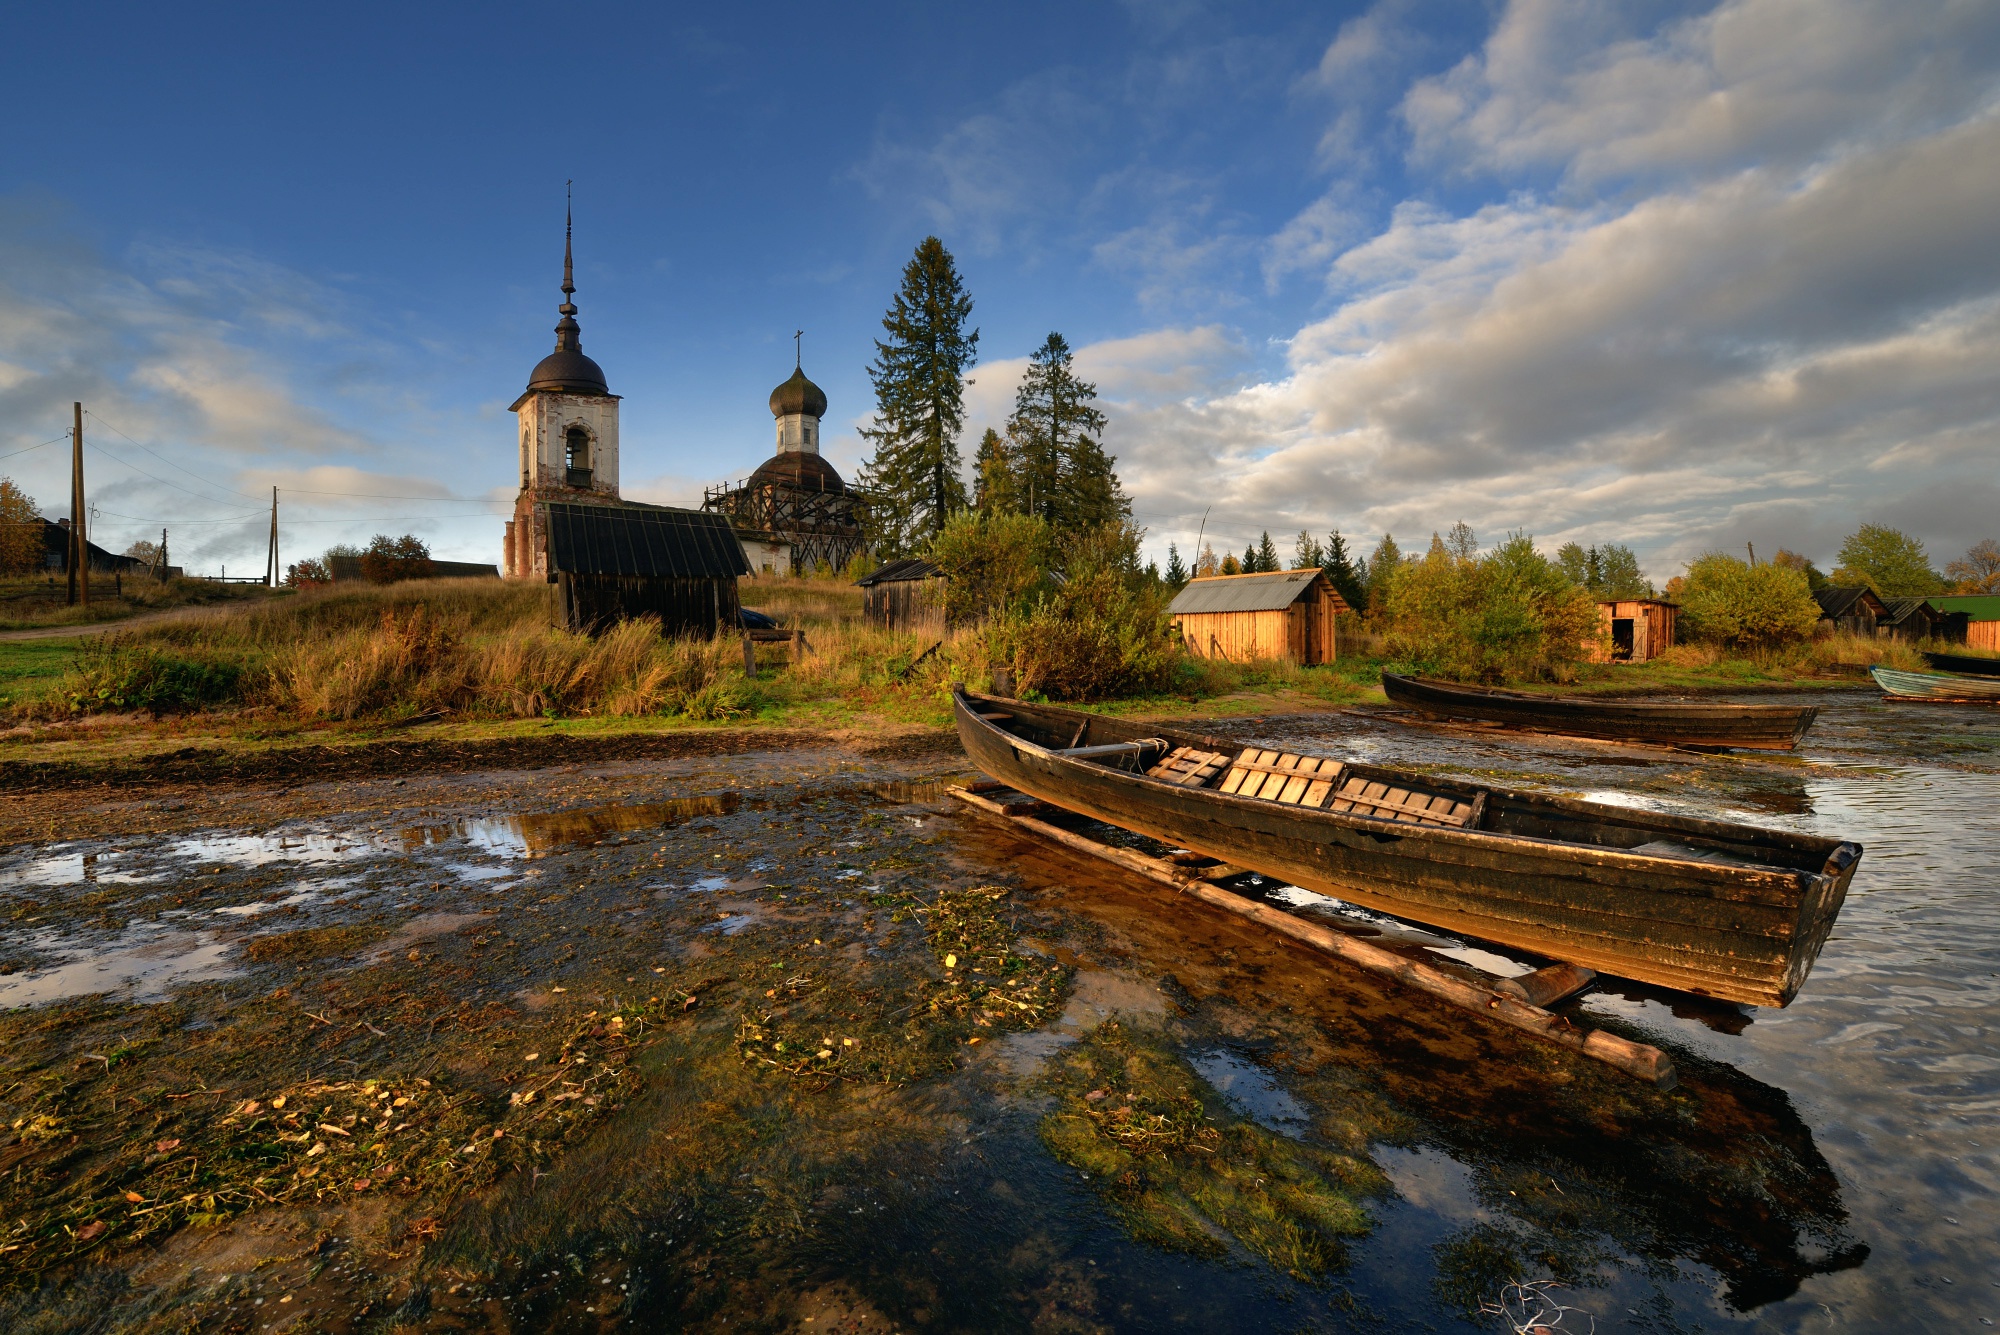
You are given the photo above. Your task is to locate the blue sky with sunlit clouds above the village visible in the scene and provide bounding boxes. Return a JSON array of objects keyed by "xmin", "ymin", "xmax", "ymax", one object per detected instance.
[{"xmin": 0, "ymin": 0, "xmax": 2000, "ymax": 582}]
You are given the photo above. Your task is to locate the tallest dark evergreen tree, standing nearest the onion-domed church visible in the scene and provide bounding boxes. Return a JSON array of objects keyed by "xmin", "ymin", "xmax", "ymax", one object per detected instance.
[{"xmin": 862, "ymin": 236, "xmax": 980, "ymax": 556}]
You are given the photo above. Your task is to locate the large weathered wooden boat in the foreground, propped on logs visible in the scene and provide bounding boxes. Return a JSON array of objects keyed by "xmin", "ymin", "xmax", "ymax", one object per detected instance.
[{"xmin": 954, "ymin": 689, "xmax": 1862, "ymax": 1005}]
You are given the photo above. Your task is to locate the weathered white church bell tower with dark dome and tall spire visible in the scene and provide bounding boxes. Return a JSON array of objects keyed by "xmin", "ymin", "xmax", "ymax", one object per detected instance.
[{"xmin": 504, "ymin": 200, "xmax": 618, "ymax": 580}]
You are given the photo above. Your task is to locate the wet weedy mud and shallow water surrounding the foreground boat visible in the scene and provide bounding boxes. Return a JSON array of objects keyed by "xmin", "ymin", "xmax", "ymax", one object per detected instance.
[{"xmin": 0, "ymin": 697, "xmax": 2000, "ymax": 1331}]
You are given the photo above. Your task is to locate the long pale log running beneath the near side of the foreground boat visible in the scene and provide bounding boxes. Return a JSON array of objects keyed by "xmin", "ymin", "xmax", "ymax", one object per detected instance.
[{"xmin": 948, "ymin": 787, "xmax": 1678, "ymax": 1089}]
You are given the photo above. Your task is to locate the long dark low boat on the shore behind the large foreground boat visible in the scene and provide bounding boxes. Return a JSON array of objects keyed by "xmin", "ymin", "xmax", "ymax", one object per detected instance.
[{"xmin": 1382, "ymin": 671, "xmax": 1820, "ymax": 751}]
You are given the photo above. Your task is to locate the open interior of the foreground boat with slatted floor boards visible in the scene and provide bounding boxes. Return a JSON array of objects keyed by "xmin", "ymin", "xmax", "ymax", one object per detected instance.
[{"xmin": 966, "ymin": 695, "xmax": 1834, "ymax": 871}]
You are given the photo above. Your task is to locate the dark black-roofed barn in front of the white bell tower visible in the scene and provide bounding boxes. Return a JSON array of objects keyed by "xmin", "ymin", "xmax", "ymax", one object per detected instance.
[{"xmin": 536, "ymin": 502, "xmax": 750, "ymax": 636}]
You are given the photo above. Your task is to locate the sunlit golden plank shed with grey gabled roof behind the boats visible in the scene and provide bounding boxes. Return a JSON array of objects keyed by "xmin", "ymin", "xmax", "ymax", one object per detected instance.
[{"xmin": 1168, "ymin": 570, "xmax": 1348, "ymax": 668}]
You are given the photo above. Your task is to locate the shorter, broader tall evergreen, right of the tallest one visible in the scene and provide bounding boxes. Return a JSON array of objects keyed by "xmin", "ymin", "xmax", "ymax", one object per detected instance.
[{"xmin": 1006, "ymin": 334, "xmax": 1132, "ymax": 530}]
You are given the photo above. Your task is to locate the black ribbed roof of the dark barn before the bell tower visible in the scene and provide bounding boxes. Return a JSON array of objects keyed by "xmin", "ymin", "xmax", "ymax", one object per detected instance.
[{"xmin": 536, "ymin": 502, "xmax": 750, "ymax": 580}]
